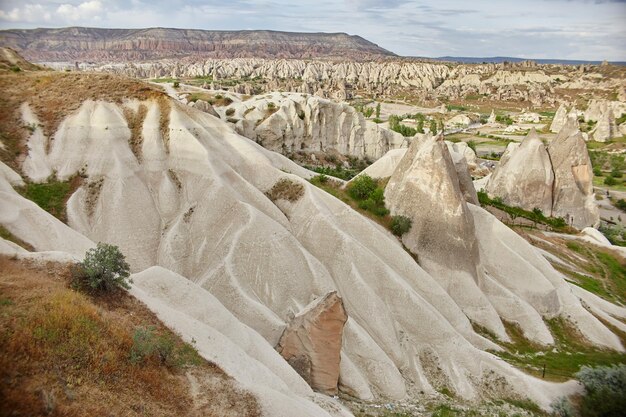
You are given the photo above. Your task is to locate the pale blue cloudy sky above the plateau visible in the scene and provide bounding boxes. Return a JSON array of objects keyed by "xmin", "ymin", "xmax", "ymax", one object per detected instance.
[{"xmin": 0, "ymin": 0, "xmax": 626, "ymax": 61}]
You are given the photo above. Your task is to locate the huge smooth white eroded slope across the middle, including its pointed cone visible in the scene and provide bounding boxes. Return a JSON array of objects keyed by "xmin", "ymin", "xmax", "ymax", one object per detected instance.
[{"xmin": 0, "ymin": 68, "xmax": 626, "ymax": 417}]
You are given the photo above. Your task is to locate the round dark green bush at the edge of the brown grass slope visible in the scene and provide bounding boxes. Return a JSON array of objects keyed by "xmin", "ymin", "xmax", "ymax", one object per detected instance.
[{"xmin": 72, "ymin": 242, "xmax": 132, "ymax": 293}]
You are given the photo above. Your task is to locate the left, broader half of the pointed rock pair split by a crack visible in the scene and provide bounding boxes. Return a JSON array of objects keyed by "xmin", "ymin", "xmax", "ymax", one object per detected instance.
[{"xmin": 486, "ymin": 128, "xmax": 554, "ymax": 214}]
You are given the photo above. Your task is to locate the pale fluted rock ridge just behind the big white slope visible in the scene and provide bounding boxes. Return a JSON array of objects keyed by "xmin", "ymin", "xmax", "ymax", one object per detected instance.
[{"xmin": 220, "ymin": 93, "xmax": 408, "ymax": 159}]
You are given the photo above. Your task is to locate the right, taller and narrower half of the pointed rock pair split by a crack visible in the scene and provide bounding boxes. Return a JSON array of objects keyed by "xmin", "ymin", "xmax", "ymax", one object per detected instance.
[{"xmin": 548, "ymin": 119, "xmax": 600, "ymax": 229}]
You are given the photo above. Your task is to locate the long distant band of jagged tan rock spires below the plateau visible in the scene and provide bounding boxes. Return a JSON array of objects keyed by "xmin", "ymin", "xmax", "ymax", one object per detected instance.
[{"xmin": 81, "ymin": 58, "xmax": 626, "ymax": 109}]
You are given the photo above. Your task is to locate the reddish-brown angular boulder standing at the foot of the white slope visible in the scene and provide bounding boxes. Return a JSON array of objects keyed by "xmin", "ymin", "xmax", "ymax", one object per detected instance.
[{"xmin": 276, "ymin": 291, "xmax": 348, "ymax": 395}]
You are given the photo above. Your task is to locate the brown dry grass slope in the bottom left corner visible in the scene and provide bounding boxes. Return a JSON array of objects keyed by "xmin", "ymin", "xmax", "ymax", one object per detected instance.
[{"xmin": 0, "ymin": 257, "xmax": 258, "ymax": 417}]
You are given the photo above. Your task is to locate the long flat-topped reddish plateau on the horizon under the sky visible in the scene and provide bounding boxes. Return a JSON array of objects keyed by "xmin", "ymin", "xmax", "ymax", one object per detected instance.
[{"xmin": 0, "ymin": 27, "xmax": 394, "ymax": 62}]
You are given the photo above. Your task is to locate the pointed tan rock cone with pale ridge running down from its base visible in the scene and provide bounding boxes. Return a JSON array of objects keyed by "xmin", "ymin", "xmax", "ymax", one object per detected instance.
[{"xmin": 385, "ymin": 135, "xmax": 508, "ymax": 339}]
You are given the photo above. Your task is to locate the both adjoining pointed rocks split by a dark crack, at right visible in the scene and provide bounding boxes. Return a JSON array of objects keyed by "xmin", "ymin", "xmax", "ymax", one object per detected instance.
[{"xmin": 486, "ymin": 123, "xmax": 599, "ymax": 229}]
